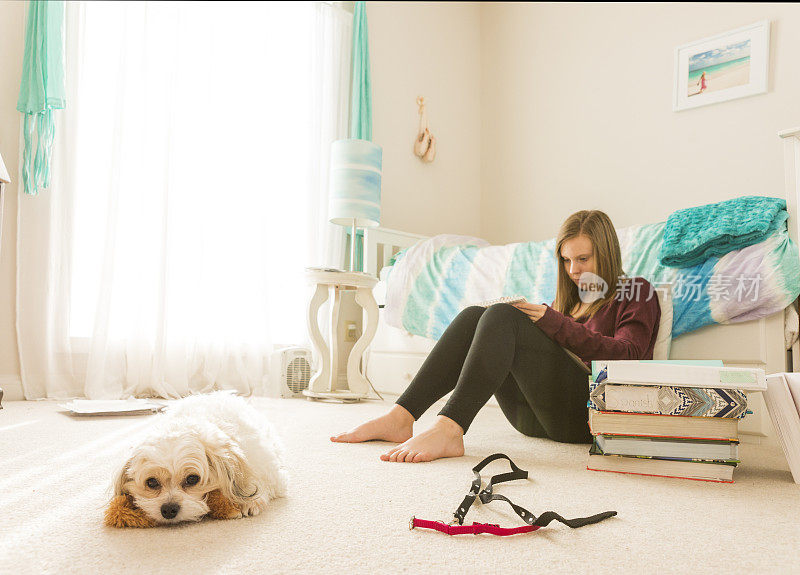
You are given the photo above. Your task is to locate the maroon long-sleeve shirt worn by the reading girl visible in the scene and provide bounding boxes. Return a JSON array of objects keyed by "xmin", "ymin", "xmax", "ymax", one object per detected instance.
[{"xmin": 536, "ymin": 277, "xmax": 661, "ymax": 364}]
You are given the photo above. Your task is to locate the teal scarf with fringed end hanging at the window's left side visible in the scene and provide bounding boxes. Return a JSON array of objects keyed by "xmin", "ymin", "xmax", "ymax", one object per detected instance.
[{"xmin": 17, "ymin": 0, "xmax": 66, "ymax": 195}]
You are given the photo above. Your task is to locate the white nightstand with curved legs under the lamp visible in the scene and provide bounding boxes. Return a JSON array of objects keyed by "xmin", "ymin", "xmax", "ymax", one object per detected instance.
[{"xmin": 303, "ymin": 270, "xmax": 378, "ymax": 400}]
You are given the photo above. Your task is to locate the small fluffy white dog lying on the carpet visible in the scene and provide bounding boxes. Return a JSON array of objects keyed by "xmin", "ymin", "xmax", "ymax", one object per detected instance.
[{"xmin": 113, "ymin": 392, "xmax": 287, "ymax": 524}]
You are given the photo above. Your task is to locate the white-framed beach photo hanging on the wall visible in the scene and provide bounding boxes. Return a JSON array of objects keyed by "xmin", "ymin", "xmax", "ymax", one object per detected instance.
[{"xmin": 672, "ymin": 20, "xmax": 769, "ymax": 112}]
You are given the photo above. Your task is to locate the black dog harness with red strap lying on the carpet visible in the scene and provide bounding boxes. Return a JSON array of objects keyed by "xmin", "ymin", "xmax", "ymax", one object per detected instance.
[{"xmin": 409, "ymin": 453, "xmax": 617, "ymax": 536}]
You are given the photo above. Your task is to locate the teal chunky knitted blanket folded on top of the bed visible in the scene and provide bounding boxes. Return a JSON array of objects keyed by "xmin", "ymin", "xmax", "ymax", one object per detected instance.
[{"xmin": 659, "ymin": 196, "xmax": 789, "ymax": 268}]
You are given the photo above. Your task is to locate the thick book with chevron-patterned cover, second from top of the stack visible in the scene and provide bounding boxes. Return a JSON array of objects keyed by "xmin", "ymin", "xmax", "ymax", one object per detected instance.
[{"xmin": 588, "ymin": 381, "xmax": 747, "ymax": 419}]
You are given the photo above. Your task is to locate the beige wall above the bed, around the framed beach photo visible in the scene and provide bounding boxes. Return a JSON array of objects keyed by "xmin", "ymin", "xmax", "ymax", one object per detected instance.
[{"xmin": 481, "ymin": 3, "xmax": 800, "ymax": 243}]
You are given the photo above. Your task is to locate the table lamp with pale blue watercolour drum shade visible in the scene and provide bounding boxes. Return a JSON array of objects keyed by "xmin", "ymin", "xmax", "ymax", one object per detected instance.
[{"xmin": 328, "ymin": 139, "xmax": 383, "ymax": 272}]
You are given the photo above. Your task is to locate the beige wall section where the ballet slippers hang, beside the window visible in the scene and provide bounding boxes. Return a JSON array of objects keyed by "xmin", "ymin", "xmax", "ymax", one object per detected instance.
[{"xmin": 367, "ymin": 2, "xmax": 481, "ymax": 235}]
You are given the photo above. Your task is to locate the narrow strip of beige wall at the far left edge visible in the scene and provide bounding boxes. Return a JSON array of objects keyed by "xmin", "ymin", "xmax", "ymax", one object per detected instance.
[{"xmin": 0, "ymin": 1, "xmax": 25, "ymax": 399}]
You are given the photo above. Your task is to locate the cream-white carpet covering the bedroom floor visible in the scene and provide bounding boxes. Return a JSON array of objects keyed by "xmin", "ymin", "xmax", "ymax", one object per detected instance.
[{"xmin": 0, "ymin": 398, "xmax": 800, "ymax": 575}]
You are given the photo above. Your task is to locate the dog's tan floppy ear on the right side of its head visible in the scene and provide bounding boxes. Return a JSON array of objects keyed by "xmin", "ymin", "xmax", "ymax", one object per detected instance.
[{"xmin": 205, "ymin": 439, "xmax": 263, "ymax": 504}]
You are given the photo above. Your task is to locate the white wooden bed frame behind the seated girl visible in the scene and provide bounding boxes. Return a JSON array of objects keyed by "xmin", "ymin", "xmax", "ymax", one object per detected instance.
[{"xmin": 364, "ymin": 128, "xmax": 800, "ymax": 436}]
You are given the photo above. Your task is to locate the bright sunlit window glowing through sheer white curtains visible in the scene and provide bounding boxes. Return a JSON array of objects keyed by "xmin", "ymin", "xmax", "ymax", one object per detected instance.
[{"xmin": 67, "ymin": 2, "xmax": 315, "ymax": 344}]
